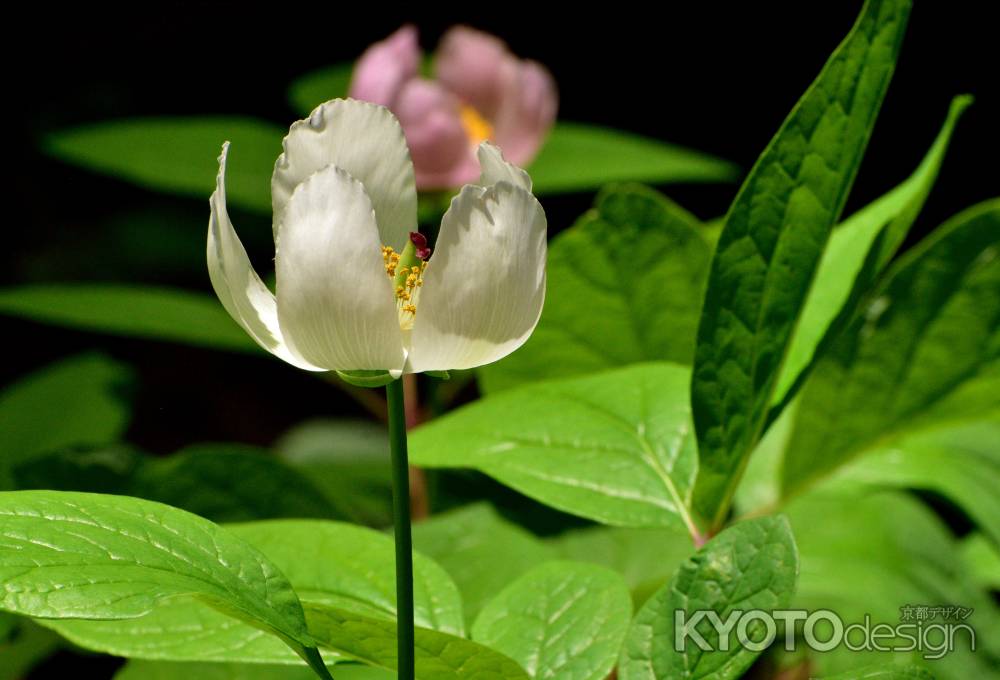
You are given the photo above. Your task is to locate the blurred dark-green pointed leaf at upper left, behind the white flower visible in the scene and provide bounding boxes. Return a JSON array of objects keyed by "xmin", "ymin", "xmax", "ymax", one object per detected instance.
[{"xmin": 42, "ymin": 116, "xmax": 285, "ymax": 215}]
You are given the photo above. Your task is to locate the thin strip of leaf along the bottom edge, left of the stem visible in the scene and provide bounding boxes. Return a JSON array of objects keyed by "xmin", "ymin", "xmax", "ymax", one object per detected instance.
[{"xmin": 114, "ymin": 661, "xmax": 386, "ymax": 680}]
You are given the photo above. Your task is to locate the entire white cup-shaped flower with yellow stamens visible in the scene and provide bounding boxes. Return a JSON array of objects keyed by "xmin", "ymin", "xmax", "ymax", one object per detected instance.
[{"xmin": 208, "ymin": 99, "xmax": 546, "ymax": 376}]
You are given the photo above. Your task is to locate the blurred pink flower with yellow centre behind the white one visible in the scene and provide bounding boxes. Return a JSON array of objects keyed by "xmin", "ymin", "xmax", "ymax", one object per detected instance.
[{"xmin": 350, "ymin": 26, "xmax": 558, "ymax": 189}]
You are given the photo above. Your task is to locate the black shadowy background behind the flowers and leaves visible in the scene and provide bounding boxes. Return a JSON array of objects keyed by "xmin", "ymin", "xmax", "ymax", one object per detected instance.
[{"xmin": 7, "ymin": 0, "xmax": 1000, "ymax": 460}]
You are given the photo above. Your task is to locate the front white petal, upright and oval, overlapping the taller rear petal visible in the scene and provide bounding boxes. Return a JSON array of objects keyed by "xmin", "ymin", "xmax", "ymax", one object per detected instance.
[{"xmin": 275, "ymin": 166, "xmax": 405, "ymax": 371}]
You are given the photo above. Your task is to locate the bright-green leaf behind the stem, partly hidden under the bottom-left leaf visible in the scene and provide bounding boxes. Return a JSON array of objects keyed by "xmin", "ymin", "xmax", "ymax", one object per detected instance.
[{"xmin": 45, "ymin": 520, "xmax": 464, "ymax": 664}]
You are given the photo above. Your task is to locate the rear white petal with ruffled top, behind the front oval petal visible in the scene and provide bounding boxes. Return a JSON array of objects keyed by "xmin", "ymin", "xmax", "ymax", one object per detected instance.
[{"xmin": 271, "ymin": 99, "xmax": 417, "ymax": 250}]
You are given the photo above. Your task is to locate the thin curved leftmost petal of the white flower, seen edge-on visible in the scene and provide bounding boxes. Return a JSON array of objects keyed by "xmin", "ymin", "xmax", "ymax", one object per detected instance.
[{"xmin": 208, "ymin": 142, "xmax": 325, "ymax": 371}]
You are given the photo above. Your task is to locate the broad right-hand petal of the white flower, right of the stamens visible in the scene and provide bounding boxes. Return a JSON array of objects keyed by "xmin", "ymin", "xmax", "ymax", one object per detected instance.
[{"xmin": 407, "ymin": 181, "xmax": 546, "ymax": 372}]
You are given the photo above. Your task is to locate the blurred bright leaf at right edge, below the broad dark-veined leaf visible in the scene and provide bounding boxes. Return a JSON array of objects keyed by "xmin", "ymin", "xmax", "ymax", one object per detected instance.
[{"xmin": 841, "ymin": 414, "xmax": 1000, "ymax": 545}]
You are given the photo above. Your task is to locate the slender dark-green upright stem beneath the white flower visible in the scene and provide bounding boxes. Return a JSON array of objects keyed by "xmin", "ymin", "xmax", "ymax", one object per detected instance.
[{"xmin": 385, "ymin": 380, "xmax": 414, "ymax": 680}]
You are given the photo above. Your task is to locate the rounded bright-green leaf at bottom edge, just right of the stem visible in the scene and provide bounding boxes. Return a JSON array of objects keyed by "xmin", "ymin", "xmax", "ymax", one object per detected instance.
[{"xmin": 472, "ymin": 562, "xmax": 632, "ymax": 680}]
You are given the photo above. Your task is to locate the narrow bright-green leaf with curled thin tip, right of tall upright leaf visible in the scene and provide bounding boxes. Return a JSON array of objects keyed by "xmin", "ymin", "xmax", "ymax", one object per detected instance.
[{"xmin": 771, "ymin": 95, "xmax": 972, "ymax": 407}]
